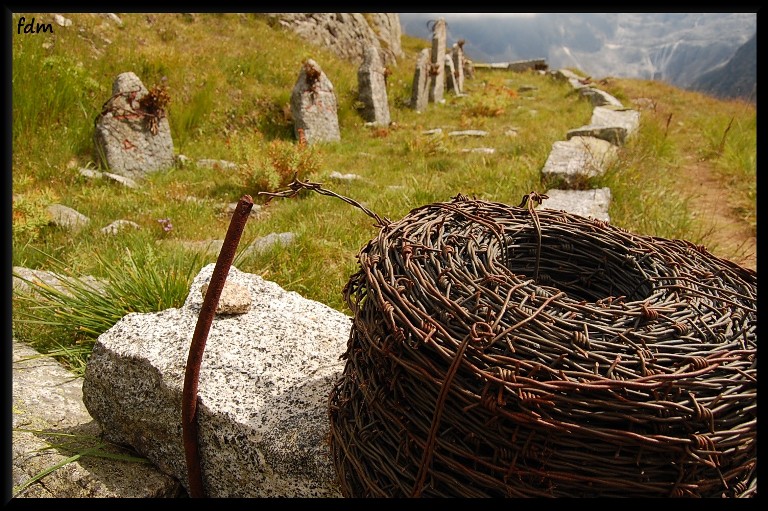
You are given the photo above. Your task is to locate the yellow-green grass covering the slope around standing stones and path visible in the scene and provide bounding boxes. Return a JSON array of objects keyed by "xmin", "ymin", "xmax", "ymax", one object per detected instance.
[{"xmin": 12, "ymin": 13, "xmax": 756, "ymax": 372}]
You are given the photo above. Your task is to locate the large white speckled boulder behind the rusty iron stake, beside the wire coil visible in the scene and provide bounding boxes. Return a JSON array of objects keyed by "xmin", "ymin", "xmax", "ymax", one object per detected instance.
[{"xmin": 83, "ymin": 264, "xmax": 352, "ymax": 497}]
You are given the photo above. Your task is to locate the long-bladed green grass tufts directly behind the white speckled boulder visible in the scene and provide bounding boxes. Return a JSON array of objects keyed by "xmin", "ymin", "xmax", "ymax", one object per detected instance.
[{"xmin": 13, "ymin": 242, "xmax": 206, "ymax": 376}]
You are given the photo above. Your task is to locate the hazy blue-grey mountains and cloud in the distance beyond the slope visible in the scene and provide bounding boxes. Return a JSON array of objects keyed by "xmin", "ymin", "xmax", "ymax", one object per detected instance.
[{"xmin": 400, "ymin": 12, "xmax": 757, "ymax": 100}]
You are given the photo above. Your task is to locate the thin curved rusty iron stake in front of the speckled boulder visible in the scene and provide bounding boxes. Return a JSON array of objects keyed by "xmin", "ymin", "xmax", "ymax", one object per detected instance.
[{"xmin": 181, "ymin": 195, "xmax": 253, "ymax": 497}]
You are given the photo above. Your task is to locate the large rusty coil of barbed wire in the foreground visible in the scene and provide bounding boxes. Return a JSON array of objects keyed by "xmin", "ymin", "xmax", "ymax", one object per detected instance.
[{"xmin": 329, "ymin": 193, "xmax": 757, "ymax": 497}]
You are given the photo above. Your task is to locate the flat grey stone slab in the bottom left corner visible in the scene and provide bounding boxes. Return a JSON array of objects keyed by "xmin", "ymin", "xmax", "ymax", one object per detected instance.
[{"xmin": 11, "ymin": 340, "xmax": 183, "ymax": 498}]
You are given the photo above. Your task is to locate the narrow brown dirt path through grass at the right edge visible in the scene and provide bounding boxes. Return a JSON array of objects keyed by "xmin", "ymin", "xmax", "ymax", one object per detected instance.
[{"xmin": 681, "ymin": 159, "xmax": 757, "ymax": 270}]
